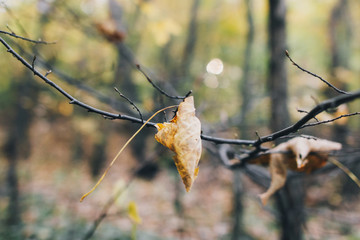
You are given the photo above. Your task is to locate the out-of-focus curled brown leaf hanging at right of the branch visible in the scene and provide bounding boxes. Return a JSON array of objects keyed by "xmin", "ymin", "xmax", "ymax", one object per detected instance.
[{"xmin": 253, "ymin": 137, "xmax": 341, "ymax": 205}]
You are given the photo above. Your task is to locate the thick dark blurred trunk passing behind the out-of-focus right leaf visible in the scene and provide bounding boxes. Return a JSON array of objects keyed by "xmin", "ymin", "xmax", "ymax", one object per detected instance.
[{"xmin": 268, "ymin": 0, "xmax": 305, "ymax": 240}]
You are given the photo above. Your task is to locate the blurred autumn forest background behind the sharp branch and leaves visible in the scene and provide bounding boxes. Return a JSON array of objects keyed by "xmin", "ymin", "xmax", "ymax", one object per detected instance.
[{"xmin": 0, "ymin": 0, "xmax": 360, "ymax": 240}]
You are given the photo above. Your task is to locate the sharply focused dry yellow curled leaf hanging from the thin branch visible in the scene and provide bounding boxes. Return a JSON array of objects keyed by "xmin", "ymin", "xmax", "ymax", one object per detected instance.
[{"xmin": 155, "ymin": 96, "xmax": 202, "ymax": 192}]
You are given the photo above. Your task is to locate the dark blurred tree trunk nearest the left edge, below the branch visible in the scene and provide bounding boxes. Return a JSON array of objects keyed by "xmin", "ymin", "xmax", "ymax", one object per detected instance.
[{"xmin": 4, "ymin": 75, "xmax": 38, "ymax": 233}]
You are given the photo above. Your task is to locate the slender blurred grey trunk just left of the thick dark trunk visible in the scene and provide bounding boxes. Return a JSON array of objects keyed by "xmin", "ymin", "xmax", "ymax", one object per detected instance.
[{"xmin": 231, "ymin": 0, "xmax": 254, "ymax": 240}]
